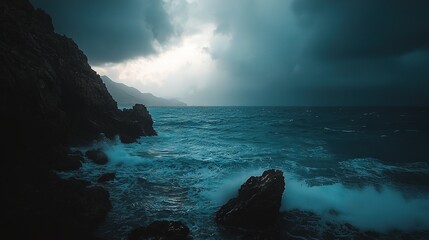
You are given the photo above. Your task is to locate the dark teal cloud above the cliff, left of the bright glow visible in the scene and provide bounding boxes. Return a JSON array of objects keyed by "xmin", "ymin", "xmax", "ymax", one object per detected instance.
[{"xmin": 31, "ymin": 0, "xmax": 174, "ymax": 64}]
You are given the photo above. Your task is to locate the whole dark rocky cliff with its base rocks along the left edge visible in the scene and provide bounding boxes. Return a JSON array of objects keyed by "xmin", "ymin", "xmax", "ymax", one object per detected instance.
[{"xmin": 0, "ymin": 0, "xmax": 156, "ymax": 239}]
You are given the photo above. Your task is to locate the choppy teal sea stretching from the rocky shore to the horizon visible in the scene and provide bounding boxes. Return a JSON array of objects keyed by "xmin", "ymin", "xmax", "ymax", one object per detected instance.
[{"xmin": 62, "ymin": 107, "xmax": 429, "ymax": 239}]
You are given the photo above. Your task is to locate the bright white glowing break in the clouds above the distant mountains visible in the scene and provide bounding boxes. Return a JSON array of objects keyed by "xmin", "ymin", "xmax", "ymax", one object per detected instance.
[{"xmin": 92, "ymin": 24, "xmax": 221, "ymax": 99}]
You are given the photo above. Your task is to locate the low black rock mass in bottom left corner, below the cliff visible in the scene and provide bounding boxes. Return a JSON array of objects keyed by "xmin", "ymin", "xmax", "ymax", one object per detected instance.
[{"xmin": 0, "ymin": 172, "xmax": 111, "ymax": 240}]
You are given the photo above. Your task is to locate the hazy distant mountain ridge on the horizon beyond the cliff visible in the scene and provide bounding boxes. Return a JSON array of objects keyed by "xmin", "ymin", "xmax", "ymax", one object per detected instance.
[{"xmin": 101, "ymin": 76, "xmax": 187, "ymax": 107}]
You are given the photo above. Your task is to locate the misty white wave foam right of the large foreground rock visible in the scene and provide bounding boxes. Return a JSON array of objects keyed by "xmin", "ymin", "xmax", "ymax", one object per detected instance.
[{"xmin": 282, "ymin": 179, "xmax": 429, "ymax": 231}]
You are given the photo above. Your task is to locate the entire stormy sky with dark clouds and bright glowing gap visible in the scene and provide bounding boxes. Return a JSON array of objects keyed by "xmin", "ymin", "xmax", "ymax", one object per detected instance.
[{"xmin": 31, "ymin": 0, "xmax": 429, "ymax": 106}]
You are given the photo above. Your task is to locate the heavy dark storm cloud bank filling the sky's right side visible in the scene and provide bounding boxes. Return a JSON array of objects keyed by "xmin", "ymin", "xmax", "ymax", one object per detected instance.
[{"xmin": 201, "ymin": 0, "xmax": 429, "ymax": 105}]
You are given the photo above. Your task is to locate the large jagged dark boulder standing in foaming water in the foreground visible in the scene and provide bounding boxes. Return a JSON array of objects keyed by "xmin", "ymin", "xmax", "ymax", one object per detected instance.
[{"xmin": 215, "ymin": 169, "xmax": 285, "ymax": 228}]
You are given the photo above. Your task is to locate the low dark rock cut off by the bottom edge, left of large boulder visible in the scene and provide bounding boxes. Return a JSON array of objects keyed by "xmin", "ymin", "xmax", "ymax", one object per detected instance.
[{"xmin": 128, "ymin": 221, "xmax": 190, "ymax": 240}]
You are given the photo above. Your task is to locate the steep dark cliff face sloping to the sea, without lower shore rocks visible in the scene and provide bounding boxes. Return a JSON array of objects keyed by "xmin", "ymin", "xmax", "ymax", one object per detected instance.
[{"xmin": 0, "ymin": 0, "xmax": 156, "ymax": 165}]
